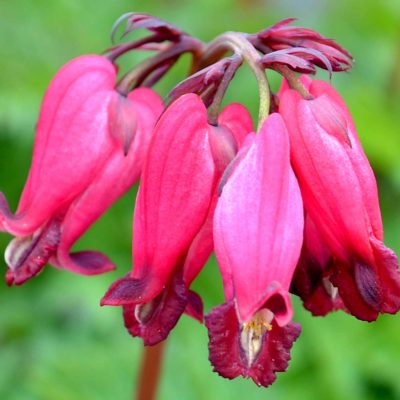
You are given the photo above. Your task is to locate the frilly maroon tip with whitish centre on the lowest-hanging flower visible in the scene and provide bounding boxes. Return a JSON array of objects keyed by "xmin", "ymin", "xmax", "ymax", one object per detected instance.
[{"xmin": 205, "ymin": 301, "xmax": 301, "ymax": 387}]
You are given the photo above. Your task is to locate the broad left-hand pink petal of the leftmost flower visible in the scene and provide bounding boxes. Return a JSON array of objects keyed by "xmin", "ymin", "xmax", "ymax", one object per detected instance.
[{"xmin": 3, "ymin": 56, "xmax": 116, "ymax": 235}]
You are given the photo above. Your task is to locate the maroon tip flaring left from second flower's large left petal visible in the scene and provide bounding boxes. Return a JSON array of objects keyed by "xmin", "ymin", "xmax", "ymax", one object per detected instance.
[{"xmin": 100, "ymin": 275, "xmax": 147, "ymax": 306}]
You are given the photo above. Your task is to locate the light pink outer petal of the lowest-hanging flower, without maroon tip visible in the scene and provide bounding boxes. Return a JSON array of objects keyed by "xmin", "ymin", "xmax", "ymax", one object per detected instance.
[{"xmin": 214, "ymin": 114, "xmax": 303, "ymax": 325}]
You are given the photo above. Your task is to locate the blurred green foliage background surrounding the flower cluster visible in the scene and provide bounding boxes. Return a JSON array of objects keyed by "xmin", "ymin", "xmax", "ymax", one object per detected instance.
[{"xmin": 0, "ymin": 0, "xmax": 400, "ymax": 400}]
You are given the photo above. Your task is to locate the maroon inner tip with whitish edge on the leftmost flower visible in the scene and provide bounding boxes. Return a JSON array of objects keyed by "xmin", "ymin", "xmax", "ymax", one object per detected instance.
[{"xmin": 5, "ymin": 219, "xmax": 60, "ymax": 286}]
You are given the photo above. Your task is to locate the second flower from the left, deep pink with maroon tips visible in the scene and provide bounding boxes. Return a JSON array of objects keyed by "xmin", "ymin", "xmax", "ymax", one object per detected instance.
[{"xmin": 102, "ymin": 94, "xmax": 252, "ymax": 345}]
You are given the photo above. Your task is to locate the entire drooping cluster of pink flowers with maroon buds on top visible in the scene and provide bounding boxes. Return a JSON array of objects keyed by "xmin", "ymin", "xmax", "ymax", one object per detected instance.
[{"xmin": 0, "ymin": 14, "xmax": 400, "ymax": 386}]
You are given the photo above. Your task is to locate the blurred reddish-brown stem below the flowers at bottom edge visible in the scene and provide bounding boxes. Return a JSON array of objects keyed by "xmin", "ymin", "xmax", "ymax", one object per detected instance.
[{"xmin": 136, "ymin": 342, "xmax": 165, "ymax": 400}]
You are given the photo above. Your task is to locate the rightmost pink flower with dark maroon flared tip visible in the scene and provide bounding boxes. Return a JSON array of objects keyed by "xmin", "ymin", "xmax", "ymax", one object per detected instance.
[{"xmin": 279, "ymin": 76, "xmax": 400, "ymax": 321}]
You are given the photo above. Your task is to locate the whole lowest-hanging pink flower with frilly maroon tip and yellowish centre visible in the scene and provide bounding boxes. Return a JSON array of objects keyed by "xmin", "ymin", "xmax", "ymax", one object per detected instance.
[{"xmin": 206, "ymin": 114, "xmax": 303, "ymax": 386}]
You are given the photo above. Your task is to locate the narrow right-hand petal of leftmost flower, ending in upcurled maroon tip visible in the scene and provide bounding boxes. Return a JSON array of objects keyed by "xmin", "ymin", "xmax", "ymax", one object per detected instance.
[{"xmin": 57, "ymin": 88, "xmax": 163, "ymax": 274}]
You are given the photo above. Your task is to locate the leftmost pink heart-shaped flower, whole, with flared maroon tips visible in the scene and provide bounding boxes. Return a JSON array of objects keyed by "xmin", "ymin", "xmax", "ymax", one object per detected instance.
[{"xmin": 0, "ymin": 55, "xmax": 162, "ymax": 285}]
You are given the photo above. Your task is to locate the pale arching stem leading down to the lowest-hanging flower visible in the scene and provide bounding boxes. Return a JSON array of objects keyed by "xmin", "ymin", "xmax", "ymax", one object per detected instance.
[{"xmin": 198, "ymin": 32, "xmax": 270, "ymax": 130}]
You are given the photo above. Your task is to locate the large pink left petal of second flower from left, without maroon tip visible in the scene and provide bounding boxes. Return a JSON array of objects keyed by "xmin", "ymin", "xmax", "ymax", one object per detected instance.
[{"xmin": 132, "ymin": 94, "xmax": 214, "ymax": 302}]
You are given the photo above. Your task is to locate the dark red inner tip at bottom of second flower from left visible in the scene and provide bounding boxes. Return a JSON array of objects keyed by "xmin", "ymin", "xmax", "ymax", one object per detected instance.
[{"xmin": 123, "ymin": 273, "xmax": 188, "ymax": 346}]
